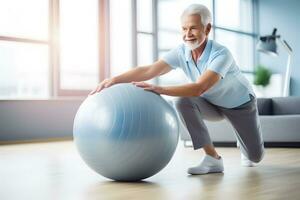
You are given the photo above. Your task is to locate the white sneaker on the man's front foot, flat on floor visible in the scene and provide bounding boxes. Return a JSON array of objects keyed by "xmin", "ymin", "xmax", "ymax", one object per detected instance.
[{"xmin": 188, "ymin": 155, "xmax": 224, "ymax": 175}]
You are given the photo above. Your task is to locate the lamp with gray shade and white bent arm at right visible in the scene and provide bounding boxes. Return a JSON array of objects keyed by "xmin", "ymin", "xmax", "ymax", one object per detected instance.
[{"xmin": 256, "ymin": 28, "xmax": 293, "ymax": 97}]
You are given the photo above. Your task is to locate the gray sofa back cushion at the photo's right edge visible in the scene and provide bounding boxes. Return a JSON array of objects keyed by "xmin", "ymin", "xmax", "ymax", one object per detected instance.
[{"xmin": 272, "ymin": 97, "xmax": 300, "ymax": 115}]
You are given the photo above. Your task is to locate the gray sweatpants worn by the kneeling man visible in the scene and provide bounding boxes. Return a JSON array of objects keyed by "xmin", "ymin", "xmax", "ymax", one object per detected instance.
[{"xmin": 176, "ymin": 96, "xmax": 264, "ymax": 162}]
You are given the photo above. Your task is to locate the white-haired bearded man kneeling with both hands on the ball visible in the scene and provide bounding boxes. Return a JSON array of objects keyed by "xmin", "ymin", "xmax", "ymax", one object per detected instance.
[{"xmin": 90, "ymin": 4, "xmax": 264, "ymax": 175}]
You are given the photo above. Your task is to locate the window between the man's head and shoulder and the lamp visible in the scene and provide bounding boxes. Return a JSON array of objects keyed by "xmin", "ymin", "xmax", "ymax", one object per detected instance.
[{"xmin": 214, "ymin": 0, "xmax": 255, "ymax": 72}]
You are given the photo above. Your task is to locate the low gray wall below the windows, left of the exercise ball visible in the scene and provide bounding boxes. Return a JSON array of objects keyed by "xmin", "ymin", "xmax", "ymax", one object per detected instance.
[{"xmin": 0, "ymin": 99, "xmax": 82, "ymax": 142}]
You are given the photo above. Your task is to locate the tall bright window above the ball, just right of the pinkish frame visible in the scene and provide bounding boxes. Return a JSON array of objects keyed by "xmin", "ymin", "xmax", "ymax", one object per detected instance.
[{"xmin": 110, "ymin": 0, "xmax": 157, "ymax": 82}]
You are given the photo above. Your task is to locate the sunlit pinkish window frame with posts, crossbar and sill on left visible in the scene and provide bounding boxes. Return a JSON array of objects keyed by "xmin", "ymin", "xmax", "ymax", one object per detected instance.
[{"xmin": 0, "ymin": 0, "xmax": 109, "ymax": 99}]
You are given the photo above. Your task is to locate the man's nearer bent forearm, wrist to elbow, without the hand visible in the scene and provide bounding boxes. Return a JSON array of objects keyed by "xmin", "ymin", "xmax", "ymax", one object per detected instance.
[{"xmin": 162, "ymin": 83, "xmax": 205, "ymax": 97}]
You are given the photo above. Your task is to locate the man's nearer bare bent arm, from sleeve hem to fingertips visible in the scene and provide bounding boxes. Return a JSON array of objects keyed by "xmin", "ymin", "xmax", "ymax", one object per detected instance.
[{"xmin": 134, "ymin": 70, "xmax": 221, "ymax": 97}]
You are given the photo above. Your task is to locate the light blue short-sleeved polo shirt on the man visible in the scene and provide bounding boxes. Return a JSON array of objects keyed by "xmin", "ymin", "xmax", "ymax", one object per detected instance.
[{"xmin": 162, "ymin": 40, "xmax": 255, "ymax": 108}]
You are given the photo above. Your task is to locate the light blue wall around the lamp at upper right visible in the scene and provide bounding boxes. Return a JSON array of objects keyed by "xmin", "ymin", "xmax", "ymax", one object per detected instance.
[{"xmin": 258, "ymin": 0, "xmax": 300, "ymax": 96}]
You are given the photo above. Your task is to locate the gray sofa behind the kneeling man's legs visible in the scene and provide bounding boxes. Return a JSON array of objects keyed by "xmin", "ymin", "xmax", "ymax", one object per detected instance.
[{"xmin": 180, "ymin": 97, "xmax": 300, "ymax": 147}]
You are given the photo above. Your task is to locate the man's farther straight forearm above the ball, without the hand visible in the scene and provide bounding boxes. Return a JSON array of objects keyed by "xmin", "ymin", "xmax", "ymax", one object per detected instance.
[{"xmin": 113, "ymin": 66, "xmax": 153, "ymax": 83}]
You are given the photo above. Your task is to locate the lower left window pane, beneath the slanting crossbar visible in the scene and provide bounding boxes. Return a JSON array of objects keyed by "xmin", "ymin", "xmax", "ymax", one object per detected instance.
[{"xmin": 0, "ymin": 40, "xmax": 49, "ymax": 99}]
